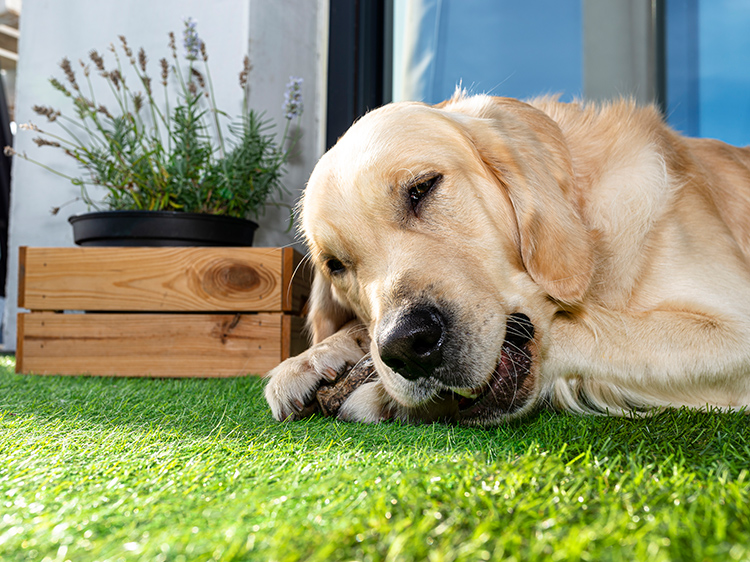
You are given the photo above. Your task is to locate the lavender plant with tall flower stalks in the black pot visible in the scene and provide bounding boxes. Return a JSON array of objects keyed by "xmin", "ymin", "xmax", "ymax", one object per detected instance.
[{"xmin": 6, "ymin": 19, "xmax": 302, "ymax": 218}]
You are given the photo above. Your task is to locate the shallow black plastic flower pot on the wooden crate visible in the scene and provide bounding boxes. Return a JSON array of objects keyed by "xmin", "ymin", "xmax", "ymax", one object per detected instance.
[{"xmin": 68, "ymin": 211, "xmax": 258, "ymax": 246}]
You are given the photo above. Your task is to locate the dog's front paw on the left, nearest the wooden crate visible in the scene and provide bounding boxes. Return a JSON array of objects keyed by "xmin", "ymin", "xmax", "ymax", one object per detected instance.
[{"xmin": 265, "ymin": 320, "xmax": 370, "ymax": 421}]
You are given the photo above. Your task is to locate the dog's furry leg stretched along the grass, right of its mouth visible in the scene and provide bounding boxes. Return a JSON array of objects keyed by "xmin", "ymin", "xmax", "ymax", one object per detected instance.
[{"xmin": 542, "ymin": 305, "xmax": 750, "ymax": 413}]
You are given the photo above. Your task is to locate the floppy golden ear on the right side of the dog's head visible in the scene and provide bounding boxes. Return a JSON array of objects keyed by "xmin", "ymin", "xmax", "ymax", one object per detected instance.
[{"xmin": 445, "ymin": 96, "xmax": 594, "ymax": 302}]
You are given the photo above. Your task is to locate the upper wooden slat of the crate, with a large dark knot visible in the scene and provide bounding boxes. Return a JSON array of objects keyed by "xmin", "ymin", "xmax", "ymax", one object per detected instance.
[{"xmin": 19, "ymin": 247, "xmax": 309, "ymax": 312}]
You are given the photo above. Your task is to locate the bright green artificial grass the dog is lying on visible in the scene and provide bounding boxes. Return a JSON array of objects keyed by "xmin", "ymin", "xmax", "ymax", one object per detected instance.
[{"xmin": 0, "ymin": 360, "xmax": 750, "ymax": 562}]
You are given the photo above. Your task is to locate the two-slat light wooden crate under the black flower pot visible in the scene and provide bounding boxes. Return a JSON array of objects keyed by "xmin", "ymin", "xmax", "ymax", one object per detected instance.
[{"xmin": 16, "ymin": 247, "xmax": 310, "ymax": 377}]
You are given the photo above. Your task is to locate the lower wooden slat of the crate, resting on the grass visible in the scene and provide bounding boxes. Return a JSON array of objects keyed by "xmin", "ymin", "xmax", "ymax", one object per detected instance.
[{"xmin": 16, "ymin": 312, "xmax": 301, "ymax": 377}]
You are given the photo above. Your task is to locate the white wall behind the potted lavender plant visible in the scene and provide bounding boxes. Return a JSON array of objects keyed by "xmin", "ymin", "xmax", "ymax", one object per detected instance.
[{"xmin": 3, "ymin": 0, "xmax": 328, "ymax": 349}]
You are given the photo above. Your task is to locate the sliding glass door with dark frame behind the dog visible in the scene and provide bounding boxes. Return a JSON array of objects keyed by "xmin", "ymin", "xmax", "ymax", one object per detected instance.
[{"xmin": 328, "ymin": 0, "xmax": 750, "ymax": 145}]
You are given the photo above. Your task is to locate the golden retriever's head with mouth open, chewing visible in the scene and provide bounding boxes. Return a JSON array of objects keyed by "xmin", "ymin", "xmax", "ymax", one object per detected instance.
[{"xmin": 301, "ymin": 96, "xmax": 593, "ymax": 424}]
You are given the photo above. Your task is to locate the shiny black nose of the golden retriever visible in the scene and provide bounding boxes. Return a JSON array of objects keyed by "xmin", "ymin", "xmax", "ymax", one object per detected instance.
[{"xmin": 378, "ymin": 307, "xmax": 445, "ymax": 380}]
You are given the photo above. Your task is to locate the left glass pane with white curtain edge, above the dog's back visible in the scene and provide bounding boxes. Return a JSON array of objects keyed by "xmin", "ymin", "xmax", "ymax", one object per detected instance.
[{"xmin": 393, "ymin": 0, "xmax": 583, "ymax": 103}]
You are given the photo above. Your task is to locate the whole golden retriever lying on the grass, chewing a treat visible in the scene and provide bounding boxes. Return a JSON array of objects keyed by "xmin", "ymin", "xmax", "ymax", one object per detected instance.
[{"xmin": 266, "ymin": 94, "xmax": 750, "ymax": 424}]
